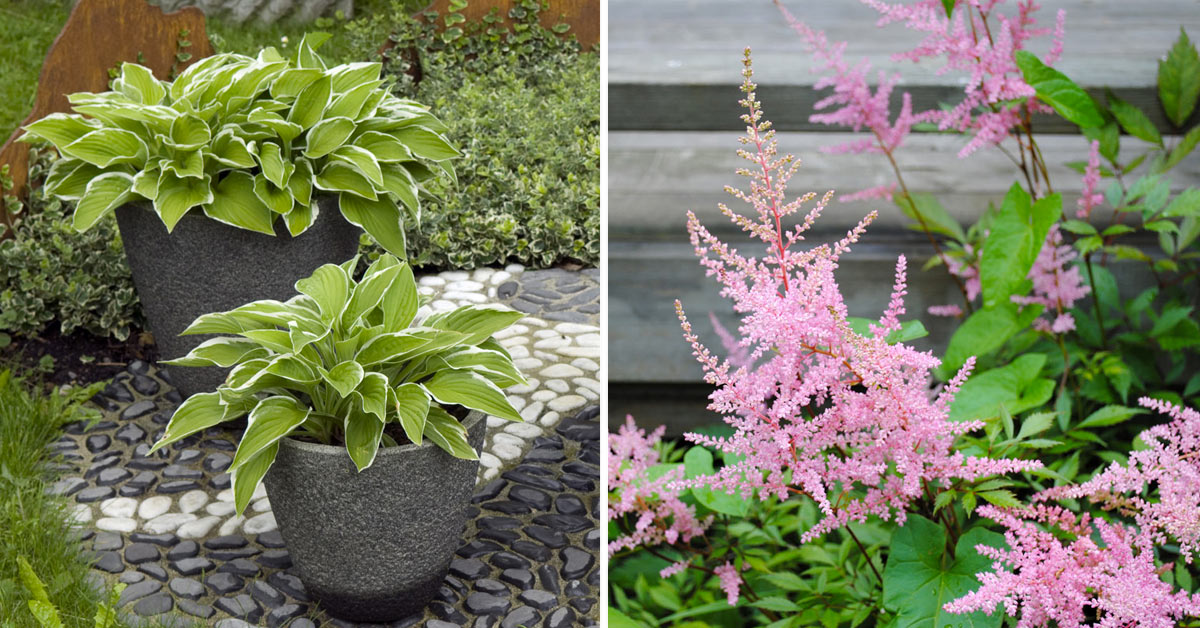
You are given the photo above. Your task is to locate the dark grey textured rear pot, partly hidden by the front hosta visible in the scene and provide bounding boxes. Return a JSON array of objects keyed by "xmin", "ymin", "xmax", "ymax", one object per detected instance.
[{"xmin": 116, "ymin": 196, "xmax": 361, "ymax": 396}]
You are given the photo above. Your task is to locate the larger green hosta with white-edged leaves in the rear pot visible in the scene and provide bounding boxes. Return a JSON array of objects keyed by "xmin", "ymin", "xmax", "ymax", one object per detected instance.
[{"xmin": 24, "ymin": 35, "xmax": 458, "ymax": 256}]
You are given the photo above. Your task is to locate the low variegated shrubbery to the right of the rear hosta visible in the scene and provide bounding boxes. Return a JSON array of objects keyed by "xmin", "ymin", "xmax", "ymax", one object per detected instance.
[{"xmin": 347, "ymin": 1, "xmax": 600, "ymax": 268}]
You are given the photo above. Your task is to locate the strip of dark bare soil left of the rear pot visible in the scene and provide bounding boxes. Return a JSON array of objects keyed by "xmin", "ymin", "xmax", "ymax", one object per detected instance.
[{"xmin": 0, "ymin": 325, "xmax": 158, "ymax": 385}]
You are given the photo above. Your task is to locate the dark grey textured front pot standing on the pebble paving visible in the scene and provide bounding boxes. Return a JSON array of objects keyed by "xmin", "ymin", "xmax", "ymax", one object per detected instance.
[{"xmin": 265, "ymin": 412, "xmax": 487, "ymax": 622}]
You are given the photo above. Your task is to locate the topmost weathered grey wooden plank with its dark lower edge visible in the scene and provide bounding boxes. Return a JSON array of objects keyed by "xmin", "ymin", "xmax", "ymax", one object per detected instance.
[{"xmin": 608, "ymin": 0, "xmax": 1200, "ymax": 132}]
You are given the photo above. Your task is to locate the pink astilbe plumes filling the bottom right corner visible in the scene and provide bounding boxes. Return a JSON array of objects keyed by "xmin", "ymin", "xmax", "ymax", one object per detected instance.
[{"xmin": 946, "ymin": 397, "xmax": 1200, "ymax": 628}]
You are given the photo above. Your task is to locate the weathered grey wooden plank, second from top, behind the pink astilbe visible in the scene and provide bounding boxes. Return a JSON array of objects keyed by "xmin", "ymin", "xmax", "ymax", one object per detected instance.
[{"xmin": 608, "ymin": 130, "xmax": 1200, "ymax": 239}]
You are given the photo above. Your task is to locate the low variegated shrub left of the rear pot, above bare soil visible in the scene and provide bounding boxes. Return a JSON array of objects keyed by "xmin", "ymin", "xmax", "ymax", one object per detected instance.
[{"xmin": 0, "ymin": 152, "xmax": 144, "ymax": 340}]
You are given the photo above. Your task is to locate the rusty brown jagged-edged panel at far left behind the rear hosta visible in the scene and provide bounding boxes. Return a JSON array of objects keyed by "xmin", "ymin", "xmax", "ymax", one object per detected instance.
[{"xmin": 0, "ymin": 0, "xmax": 212, "ymax": 212}]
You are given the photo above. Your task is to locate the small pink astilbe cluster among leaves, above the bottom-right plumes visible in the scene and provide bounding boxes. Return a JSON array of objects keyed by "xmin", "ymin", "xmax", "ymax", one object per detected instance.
[{"xmin": 1013, "ymin": 225, "xmax": 1092, "ymax": 334}]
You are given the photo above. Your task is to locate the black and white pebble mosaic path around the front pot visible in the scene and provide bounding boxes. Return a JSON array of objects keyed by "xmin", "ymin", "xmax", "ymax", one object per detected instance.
[{"xmin": 45, "ymin": 267, "xmax": 600, "ymax": 628}]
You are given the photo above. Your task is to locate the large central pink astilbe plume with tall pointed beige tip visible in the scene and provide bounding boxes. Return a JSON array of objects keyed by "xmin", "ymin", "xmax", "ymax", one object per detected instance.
[{"xmin": 676, "ymin": 49, "xmax": 1039, "ymax": 540}]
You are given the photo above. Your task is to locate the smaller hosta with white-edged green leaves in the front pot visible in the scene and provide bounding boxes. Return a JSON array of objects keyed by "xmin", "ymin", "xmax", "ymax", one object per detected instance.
[{"xmin": 144, "ymin": 255, "xmax": 524, "ymax": 512}]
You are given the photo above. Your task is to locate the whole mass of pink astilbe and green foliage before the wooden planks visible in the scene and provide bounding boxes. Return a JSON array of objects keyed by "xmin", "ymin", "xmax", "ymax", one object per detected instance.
[{"xmin": 608, "ymin": 0, "xmax": 1200, "ymax": 628}]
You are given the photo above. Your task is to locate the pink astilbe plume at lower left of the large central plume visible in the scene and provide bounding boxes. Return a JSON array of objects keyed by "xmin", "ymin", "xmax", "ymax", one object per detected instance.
[{"xmin": 608, "ymin": 417, "xmax": 713, "ymax": 559}]
